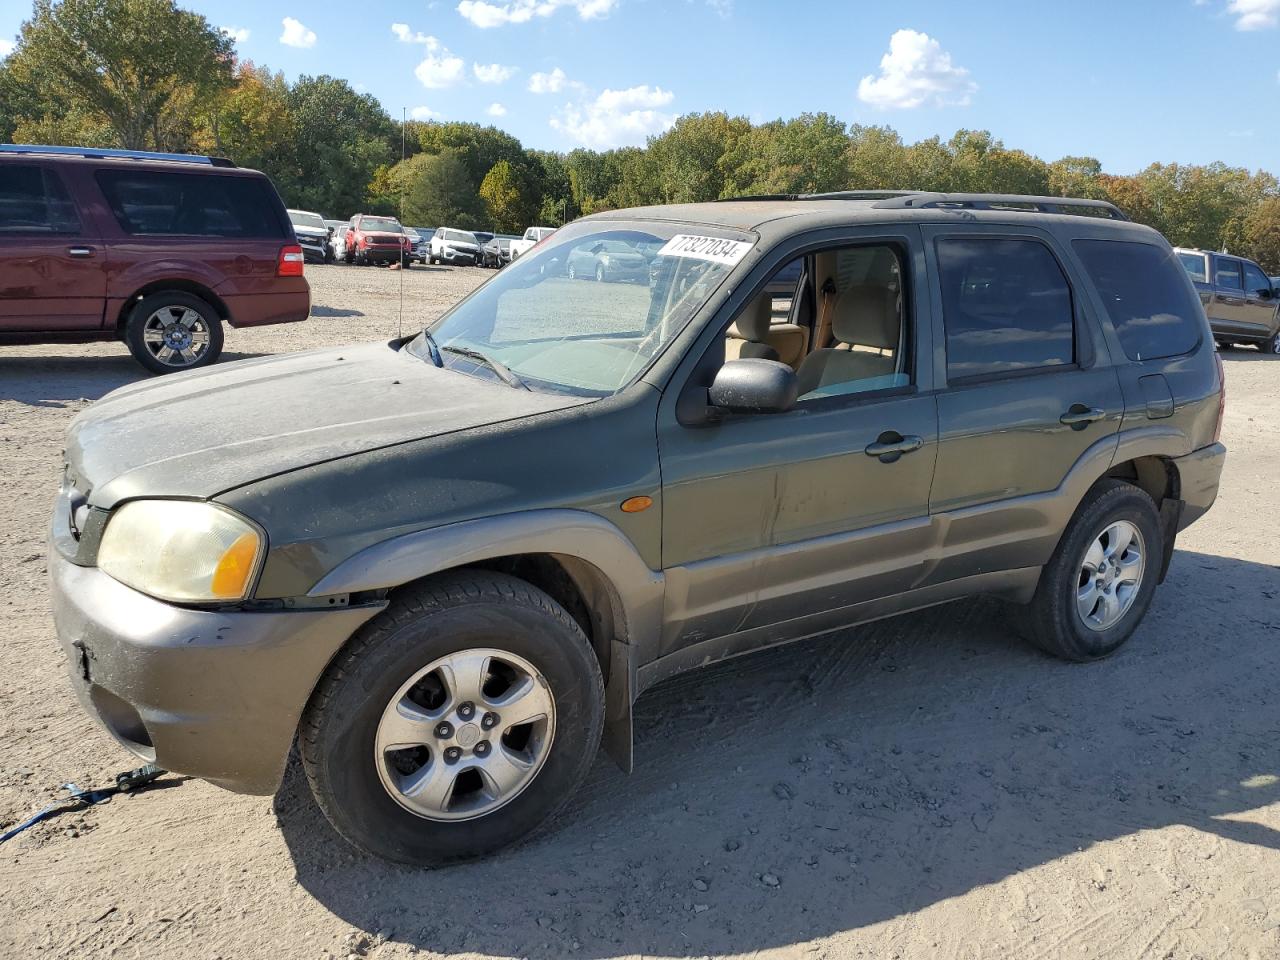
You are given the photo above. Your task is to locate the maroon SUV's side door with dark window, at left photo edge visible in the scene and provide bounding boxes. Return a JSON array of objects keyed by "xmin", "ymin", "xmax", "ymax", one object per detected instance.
[{"xmin": 0, "ymin": 163, "xmax": 106, "ymax": 332}]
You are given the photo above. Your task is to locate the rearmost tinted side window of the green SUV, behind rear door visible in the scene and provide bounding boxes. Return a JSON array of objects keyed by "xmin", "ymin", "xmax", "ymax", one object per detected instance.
[{"xmin": 1071, "ymin": 241, "xmax": 1201, "ymax": 360}]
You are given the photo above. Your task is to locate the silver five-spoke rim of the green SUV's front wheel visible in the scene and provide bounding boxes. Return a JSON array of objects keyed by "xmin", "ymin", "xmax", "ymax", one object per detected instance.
[{"xmin": 374, "ymin": 649, "xmax": 556, "ymax": 820}]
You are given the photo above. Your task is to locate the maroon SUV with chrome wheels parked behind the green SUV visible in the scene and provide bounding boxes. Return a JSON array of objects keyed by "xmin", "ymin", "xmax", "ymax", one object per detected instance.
[{"xmin": 0, "ymin": 145, "xmax": 311, "ymax": 374}]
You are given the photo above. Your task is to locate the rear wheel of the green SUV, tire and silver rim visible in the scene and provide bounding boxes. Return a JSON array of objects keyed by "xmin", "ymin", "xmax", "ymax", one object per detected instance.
[{"xmin": 1013, "ymin": 480, "xmax": 1165, "ymax": 660}]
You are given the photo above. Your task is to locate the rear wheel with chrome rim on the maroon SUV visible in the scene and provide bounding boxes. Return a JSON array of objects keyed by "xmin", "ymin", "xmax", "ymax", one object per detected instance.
[{"xmin": 124, "ymin": 291, "xmax": 223, "ymax": 374}]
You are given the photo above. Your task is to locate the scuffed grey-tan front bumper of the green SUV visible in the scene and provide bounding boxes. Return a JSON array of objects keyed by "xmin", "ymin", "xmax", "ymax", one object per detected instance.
[{"xmin": 49, "ymin": 545, "xmax": 384, "ymax": 794}]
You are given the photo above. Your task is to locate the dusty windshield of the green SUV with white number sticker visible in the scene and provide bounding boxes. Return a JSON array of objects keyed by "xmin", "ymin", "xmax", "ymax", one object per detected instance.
[{"xmin": 408, "ymin": 221, "xmax": 753, "ymax": 397}]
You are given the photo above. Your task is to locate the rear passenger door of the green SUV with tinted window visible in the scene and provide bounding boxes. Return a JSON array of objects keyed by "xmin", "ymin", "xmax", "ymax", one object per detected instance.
[{"xmin": 924, "ymin": 224, "xmax": 1124, "ymax": 582}]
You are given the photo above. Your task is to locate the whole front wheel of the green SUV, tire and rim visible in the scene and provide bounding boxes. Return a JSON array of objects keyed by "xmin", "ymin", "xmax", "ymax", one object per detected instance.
[{"xmin": 298, "ymin": 571, "xmax": 604, "ymax": 865}]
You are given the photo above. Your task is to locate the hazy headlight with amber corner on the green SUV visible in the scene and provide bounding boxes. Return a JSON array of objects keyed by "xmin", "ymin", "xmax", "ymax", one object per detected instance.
[{"xmin": 97, "ymin": 500, "xmax": 266, "ymax": 603}]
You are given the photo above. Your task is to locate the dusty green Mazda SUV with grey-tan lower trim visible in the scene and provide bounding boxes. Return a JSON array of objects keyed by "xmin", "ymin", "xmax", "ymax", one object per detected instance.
[{"xmin": 50, "ymin": 193, "xmax": 1225, "ymax": 864}]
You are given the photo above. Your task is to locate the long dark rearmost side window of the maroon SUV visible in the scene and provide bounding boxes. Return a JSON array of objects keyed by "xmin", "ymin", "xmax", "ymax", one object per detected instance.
[{"xmin": 97, "ymin": 170, "xmax": 285, "ymax": 239}]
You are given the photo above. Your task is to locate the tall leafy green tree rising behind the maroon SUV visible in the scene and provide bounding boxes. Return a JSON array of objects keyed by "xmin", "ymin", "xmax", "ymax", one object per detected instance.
[{"xmin": 8, "ymin": 0, "xmax": 232, "ymax": 150}]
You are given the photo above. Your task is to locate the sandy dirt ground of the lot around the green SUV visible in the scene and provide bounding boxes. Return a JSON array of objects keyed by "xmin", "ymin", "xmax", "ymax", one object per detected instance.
[{"xmin": 0, "ymin": 266, "xmax": 1280, "ymax": 960}]
